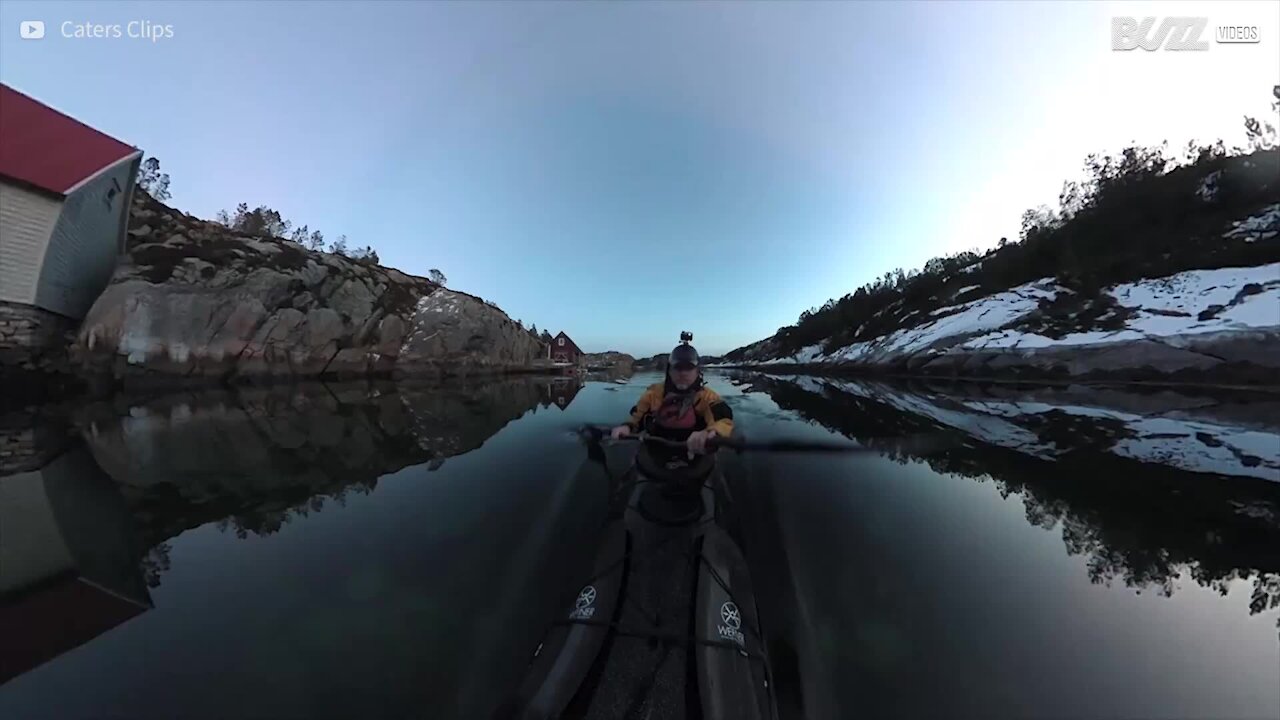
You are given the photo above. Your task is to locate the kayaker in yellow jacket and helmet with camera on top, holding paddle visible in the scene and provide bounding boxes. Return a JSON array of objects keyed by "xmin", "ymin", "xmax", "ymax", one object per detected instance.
[{"xmin": 611, "ymin": 333, "xmax": 733, "ymax": 457}]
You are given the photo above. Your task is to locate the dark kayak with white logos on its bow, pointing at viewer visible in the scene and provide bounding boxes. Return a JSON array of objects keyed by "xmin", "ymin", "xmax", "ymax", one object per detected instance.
[{"xmin": 498, "ymin": 427, "xmax": 777, "ymax": 720}]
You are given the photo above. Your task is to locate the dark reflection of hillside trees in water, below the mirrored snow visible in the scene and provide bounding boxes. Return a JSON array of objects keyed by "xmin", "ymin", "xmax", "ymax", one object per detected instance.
[{"xmin": 751, "ymin": 377, "xmax": 1280, "ymax": 614}]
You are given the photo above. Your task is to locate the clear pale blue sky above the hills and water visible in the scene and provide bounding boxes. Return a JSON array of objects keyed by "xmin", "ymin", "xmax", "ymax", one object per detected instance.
[{"xmin": 0, "ymin": 0, "xmax": 1280, "ymax": 356}]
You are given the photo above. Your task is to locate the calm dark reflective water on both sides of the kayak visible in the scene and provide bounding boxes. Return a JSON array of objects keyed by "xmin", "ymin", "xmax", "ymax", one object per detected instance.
[{"xmin": 0, "ymin": 375, "xmax": 1280, "ymax": 720}]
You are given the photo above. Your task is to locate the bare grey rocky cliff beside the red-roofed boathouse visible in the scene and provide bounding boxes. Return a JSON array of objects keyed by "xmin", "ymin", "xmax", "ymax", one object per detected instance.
[{"xmin": 73, "ymin": 192, "xmax": 539, "ymax": 380}]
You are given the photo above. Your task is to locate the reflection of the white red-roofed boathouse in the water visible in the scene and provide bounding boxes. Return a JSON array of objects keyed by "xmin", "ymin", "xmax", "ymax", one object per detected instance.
[{"xmin": 0, "ymin": 447, "xmax": 151, "ymax": 683}]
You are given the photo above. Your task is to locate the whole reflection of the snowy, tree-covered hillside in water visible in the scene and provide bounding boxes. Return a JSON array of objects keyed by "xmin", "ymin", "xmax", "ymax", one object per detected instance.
[{"xmin": 737, "ymin": 374, "xmax": 1280, "ymax": 612}]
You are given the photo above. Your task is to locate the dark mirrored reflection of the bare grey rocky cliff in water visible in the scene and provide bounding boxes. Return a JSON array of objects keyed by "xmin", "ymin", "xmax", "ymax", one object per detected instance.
[{"xmin": 79, "ymin": 378, "xmax": 539, "ymax": 561}]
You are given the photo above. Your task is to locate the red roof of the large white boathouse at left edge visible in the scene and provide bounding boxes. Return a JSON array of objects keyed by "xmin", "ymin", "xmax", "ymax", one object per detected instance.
[{"xmin": 0, "ymin": 85, "xmax": 137, "ymax": 195}]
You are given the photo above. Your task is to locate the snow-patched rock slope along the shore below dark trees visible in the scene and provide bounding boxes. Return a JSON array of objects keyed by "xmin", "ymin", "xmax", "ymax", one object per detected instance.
[{"xmin": 733, "ymin": 204, "xmax": 1280, "ymax": 379}]
